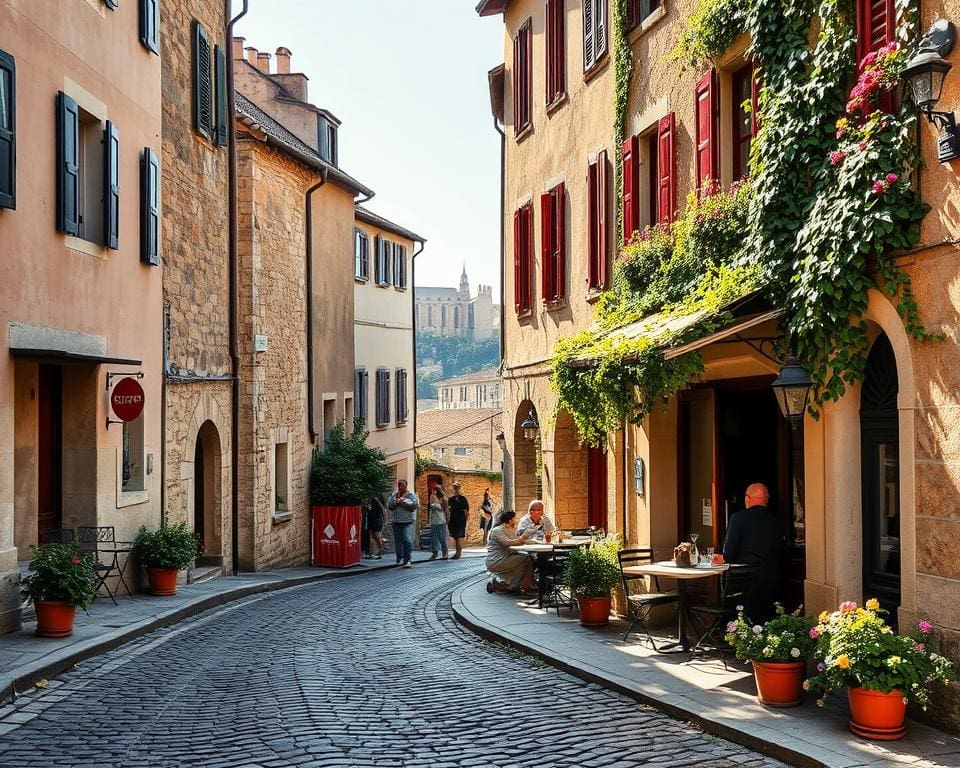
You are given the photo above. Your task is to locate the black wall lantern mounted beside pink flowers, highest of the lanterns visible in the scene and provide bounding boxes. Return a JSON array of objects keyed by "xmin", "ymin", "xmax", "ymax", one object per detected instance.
[{"xmin": 901, "ymin": 20, "xmax": 960, "ymax": 163}]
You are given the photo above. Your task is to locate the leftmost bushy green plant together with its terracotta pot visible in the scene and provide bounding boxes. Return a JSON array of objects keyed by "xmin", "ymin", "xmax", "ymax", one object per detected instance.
[{"xmin": 20, "ymin": 542, "xmax": 96, "ymax": 637}]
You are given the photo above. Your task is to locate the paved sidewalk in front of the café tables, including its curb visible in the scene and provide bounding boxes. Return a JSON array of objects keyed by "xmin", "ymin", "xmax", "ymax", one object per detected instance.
[{"xmin": 453, "ymin": 577, "xmax": 960, "ymax": 768}]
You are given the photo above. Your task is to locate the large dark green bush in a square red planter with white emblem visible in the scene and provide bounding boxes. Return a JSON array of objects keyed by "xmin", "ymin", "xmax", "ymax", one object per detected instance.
[{"xmin": 310, "ymin": 419, "xmax": 391, "ymax": 567}]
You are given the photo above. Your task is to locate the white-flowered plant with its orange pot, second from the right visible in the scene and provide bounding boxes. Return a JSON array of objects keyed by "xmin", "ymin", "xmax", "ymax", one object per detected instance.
[{"xmin": 726, "ymin": 603, "xmax": 817, "ymax": 707}]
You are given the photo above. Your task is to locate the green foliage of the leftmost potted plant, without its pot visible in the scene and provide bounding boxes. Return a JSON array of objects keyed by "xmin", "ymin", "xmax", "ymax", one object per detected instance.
[{"xmin": 20, "ymin": 542, "xmax": 94, "ymax": 608}]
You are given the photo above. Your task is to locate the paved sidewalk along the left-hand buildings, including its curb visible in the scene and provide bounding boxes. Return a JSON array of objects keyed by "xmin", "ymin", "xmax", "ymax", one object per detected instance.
[{"xmin": 0, "ymin": 551, "xmax": 429, "ymax": 702}]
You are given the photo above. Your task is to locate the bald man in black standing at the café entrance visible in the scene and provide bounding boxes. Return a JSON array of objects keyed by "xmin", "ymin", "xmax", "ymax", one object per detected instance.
[{"xmin": 723, "ymin": 483, "xmax": 786, "ymax": 622}]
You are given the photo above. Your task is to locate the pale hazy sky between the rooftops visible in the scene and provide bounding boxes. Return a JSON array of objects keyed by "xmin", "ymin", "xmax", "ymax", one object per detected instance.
[{"xmin": 234, "ymin": 0, "xmax": 503, "ymax": 300}]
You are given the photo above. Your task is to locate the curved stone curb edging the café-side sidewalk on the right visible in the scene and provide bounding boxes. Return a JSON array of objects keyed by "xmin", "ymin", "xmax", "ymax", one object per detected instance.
[{"xmin": 451, "ymin": 576, "xmax": 829, "ymax": 768}]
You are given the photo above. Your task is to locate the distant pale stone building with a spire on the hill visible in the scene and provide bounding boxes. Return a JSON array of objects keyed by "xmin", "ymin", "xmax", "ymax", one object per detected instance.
[{"xmin": 414, "ymin": 265, "xmax": 497, "ymax": 339}]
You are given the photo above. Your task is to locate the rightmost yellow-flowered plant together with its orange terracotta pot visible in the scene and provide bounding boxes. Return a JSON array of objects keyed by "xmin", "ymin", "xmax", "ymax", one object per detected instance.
[{"xmin": 804, "ymin": 599, "xmax": 955, "ymax": 739}]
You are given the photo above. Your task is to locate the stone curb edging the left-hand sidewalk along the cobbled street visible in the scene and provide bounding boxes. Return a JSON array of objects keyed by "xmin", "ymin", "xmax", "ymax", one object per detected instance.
[{"xmin": 0, "ymin": 563, "xmax": 399, "ymax": 702}]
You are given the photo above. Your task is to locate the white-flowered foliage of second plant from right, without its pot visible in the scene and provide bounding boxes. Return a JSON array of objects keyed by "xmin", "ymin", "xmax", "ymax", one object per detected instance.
[{"xmin": 725, "ymin": 603, "xmax": 816, "ymax": 662}]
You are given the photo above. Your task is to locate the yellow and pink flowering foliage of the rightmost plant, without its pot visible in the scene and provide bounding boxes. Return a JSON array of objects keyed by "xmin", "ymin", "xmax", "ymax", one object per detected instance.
[{"xmin": 803, "ymin": 598, "xmax": 955, "ymax": 708}]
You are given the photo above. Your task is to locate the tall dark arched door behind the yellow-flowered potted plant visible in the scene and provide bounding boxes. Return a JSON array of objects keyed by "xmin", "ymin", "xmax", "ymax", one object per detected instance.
[{"xmin": 860, "ymin": 333, "xmax": 901, "ymax": 621}]
